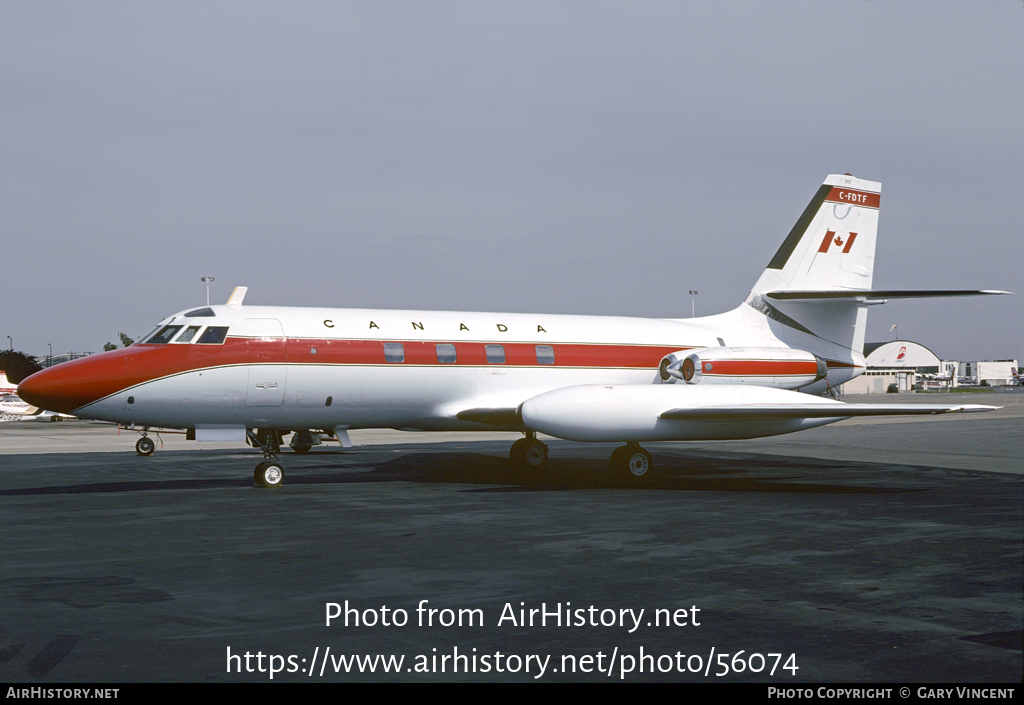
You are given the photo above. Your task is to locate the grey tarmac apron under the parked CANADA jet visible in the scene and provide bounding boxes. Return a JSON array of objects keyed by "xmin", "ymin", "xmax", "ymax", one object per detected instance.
[{"xmin": 0, "ymin": 390, "xmax": 1024, "ymax": 686}]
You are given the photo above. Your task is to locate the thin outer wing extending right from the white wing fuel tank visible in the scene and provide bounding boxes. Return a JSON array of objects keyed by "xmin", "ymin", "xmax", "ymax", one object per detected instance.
[{"xmin": 658, "ymin": 404, "xmax": 1002, "ymax": 421}]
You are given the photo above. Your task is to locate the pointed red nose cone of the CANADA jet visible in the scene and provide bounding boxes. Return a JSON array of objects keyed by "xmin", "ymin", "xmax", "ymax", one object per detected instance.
[{"xmin": 17, "ymin": 350, "xmax": 127, "ymax": 414}]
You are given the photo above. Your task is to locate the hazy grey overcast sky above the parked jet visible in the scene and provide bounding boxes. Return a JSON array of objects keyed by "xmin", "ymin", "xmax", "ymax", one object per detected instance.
[{"xmin": 0, "ymin": 0, "xmax": 1024, "ymax": 360}]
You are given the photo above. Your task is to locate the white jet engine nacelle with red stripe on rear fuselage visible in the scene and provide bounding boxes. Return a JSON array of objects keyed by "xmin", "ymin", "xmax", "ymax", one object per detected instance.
[{"xmin": 658, "ymin": 347, "xmax": 828, "ymax": 389}]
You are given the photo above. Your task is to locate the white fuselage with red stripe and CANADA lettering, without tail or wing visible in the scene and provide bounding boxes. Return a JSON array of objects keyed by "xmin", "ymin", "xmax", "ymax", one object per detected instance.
[{"xmin": 19, "ymin": 305, "xmax": 863, "ymax": 430}]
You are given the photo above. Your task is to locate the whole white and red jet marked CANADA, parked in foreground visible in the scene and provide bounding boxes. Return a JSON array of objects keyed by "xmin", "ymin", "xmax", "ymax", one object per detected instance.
[{"xmin": 18, "ymin": 174, "xmax": 1009, "ymax": 487}]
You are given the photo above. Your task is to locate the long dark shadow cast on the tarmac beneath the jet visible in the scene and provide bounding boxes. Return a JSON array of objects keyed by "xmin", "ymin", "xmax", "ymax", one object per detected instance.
[{"xmin": 0, "ymin": 451, "xmax": 924, "ymax": 496}]
